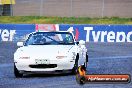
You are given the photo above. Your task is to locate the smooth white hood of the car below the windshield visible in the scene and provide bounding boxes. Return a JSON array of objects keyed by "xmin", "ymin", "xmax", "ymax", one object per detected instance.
[{"xmin": 18, "ymin": 45, "xmax": 76, "ymax": 57}]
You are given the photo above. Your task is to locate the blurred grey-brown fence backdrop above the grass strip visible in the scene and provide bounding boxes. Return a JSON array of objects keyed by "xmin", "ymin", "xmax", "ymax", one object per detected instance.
[{"xmin": 0, "ymin": 0, "xmax": 132, "ymax": 17}]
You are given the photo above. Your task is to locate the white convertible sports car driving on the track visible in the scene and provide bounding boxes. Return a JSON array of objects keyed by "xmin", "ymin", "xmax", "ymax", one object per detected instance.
[{"xmin": 14, "ymin": 31, "xmax": 88, "ymax": 77}]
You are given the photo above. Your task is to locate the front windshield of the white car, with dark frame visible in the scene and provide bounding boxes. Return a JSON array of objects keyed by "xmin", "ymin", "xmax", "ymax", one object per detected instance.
[{"xmin": 25, "ymin": 32, "xmax": 74, "ymax": 45}]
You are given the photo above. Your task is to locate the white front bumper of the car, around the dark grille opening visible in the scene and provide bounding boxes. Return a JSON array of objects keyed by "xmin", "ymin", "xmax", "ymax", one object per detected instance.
[{"xmin": 14, "ymin": 59, "xmax": 75, "ymax": 73}]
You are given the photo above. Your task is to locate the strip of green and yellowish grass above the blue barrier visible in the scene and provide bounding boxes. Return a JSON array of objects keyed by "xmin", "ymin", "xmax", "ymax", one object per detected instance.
[{"xmin": 0, "ymin": 16, "xmax": 132, "ymax": 24}]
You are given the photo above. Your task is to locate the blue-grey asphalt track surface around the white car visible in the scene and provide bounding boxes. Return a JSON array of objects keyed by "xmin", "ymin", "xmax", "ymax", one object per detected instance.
[{"xmin": 0, "ymin": 42, "xmax": 132, "ymax": 88}]
